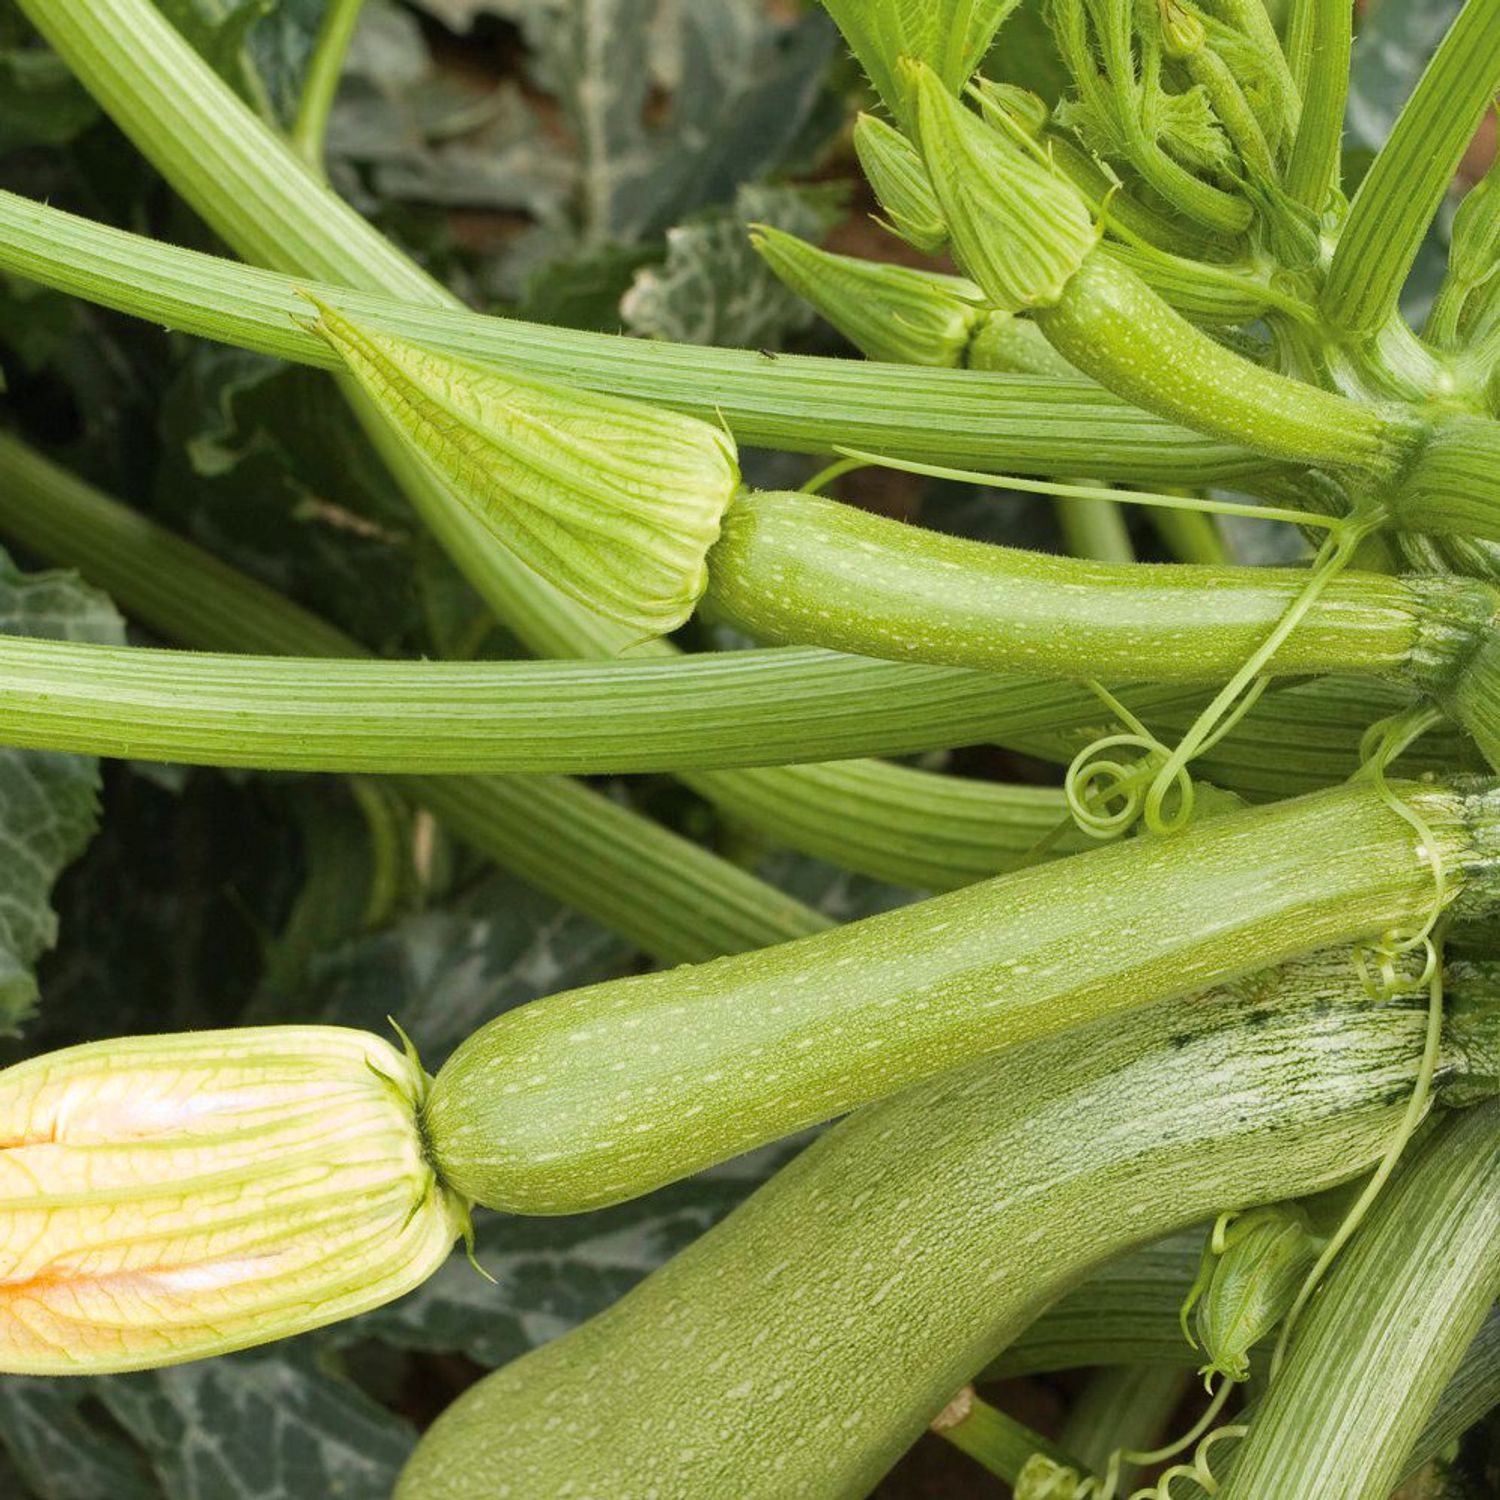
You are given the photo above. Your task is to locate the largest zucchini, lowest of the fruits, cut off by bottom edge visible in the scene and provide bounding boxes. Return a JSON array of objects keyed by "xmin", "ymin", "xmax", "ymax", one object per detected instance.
[{"xmin": 398, "ymin": 948, "xmax": 1496, "ymax": 1500}]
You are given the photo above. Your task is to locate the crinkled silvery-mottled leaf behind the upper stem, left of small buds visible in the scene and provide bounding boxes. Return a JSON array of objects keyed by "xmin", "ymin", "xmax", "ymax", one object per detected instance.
[{"xmin": 621, "ymin": 186, "xmax": 843, "ymax": 348}]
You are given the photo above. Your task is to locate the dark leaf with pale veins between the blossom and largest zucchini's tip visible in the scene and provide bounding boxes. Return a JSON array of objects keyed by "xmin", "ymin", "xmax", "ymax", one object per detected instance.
[{"xmin": 95, "ymin": 1341, "xmax": 416, "ymax": 1500}]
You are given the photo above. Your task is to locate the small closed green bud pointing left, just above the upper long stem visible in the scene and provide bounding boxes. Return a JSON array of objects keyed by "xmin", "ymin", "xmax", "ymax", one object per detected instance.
[{"xmin": 750, "ymin": 225, "xmax": 984, "ymax": 369}]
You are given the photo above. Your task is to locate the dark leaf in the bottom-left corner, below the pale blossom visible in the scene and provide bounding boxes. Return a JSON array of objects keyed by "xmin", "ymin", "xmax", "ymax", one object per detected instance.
[{"xmin": 0, "ymin": 1376, "xmax": 162, "ymax": 1500}]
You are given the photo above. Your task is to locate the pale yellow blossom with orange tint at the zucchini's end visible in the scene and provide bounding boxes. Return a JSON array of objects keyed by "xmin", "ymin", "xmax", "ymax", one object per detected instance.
[{"xmin": 0, "ymin": 1026, "xmax": 467, "ymax": 1374}]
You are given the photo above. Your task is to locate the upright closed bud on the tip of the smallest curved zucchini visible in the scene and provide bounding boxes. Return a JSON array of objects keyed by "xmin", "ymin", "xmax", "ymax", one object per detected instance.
[{"xmin": 911, "ymin": 65, "xmax": 1100, "ymax": 312}]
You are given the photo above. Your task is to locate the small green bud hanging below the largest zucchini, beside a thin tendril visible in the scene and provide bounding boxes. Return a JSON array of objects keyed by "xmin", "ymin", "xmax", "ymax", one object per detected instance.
[{"xmin": 1182, "ymin": 1203, "xmax": 1323, "ymax": 1382}]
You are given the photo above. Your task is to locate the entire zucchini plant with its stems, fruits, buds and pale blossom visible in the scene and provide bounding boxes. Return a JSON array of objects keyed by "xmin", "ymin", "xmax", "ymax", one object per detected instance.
[{"xmin": 0, "ymin": 0, "xmax": 1500, "ymax": 1500}]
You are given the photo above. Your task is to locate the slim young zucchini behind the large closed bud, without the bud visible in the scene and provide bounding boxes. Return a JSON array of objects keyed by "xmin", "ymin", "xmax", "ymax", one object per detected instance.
[{"xmin": 707, "ymin": 494, "xmax": 1497, "ymax": 689}]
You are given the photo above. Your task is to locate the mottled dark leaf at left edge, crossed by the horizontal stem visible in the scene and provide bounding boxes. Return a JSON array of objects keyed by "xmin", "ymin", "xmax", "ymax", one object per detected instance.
[{"xmin": 0, "ymin": 552, "xmax": 125, "ymax": 1032}]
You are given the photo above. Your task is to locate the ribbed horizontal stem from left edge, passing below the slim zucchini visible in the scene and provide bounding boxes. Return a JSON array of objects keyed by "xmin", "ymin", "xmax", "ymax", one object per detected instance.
[{"xmin": 0, "ymin": 638, "xmax": 1122, "ymax": 776}]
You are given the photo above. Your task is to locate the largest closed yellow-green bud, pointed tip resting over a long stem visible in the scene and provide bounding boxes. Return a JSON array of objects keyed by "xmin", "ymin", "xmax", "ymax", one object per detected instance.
[{"xmin": 315, "ymin": 303, "xmax": 740, "ymax": 638}]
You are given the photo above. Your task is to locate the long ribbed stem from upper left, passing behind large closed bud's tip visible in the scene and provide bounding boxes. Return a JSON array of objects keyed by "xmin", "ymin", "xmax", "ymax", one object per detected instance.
[{"xmin": 0, "ymin": 189, "xmax": 1266, "ymax": 485}]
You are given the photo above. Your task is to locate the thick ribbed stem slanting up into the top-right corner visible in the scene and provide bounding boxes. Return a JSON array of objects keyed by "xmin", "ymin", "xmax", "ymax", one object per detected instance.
[{"xmin": 1322, "ymin": 0, "xmax": 1500, "ymax": 336}]
